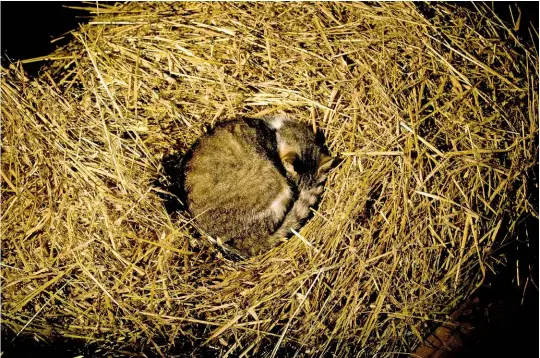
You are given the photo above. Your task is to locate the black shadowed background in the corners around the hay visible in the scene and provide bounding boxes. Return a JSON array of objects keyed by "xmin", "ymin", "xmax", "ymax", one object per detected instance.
[{"xmin": 0, "ymin": 1, "xmax": 539, "ymax": 358}]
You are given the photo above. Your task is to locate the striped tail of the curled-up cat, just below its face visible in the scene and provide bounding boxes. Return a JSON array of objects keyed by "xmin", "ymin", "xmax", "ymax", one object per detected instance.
[{"xmin": 270, "ymin": 185, "xmax": 324, "ymax": 244}]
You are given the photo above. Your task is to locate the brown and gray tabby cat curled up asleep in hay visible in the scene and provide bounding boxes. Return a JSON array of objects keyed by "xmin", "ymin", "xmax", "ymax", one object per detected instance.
[{"xmin": 181, "ymin": 116, "xmax": 333, "ymax": 257}]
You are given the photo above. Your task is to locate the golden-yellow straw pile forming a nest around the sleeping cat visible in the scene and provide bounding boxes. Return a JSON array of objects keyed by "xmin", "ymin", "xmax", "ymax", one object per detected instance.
[{"xmin": 1, "ymin": 3, "xmax": 538, "ymax": 356}]
